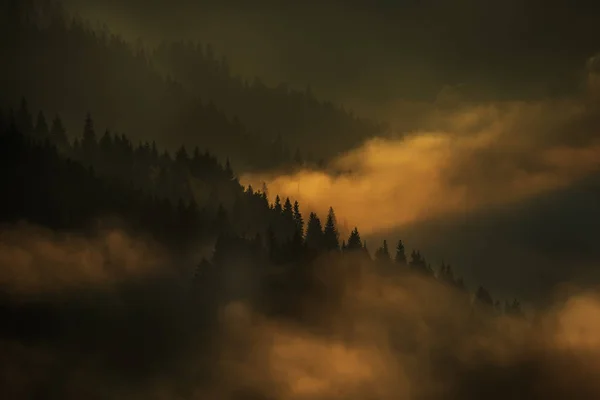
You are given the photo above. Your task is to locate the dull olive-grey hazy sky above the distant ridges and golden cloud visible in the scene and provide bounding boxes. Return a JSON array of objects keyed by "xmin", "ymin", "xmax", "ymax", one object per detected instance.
[{"xmin": 65, "ymin": 0, "xmax": 600, "ymax": 108}]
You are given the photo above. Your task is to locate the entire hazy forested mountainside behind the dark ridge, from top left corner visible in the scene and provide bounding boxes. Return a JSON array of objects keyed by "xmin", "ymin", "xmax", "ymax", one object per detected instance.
[{"xmin": 0, "ymin": 0, "xmax": 384, "ymax": 174}]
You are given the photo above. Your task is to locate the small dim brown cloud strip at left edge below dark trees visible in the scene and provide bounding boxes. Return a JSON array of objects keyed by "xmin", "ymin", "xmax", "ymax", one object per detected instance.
[{"xmin": 0, "ymin": 224, "xmax": 166, "ymax": 295}]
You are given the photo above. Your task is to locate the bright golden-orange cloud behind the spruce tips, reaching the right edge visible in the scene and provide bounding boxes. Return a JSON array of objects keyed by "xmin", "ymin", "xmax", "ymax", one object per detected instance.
[{"xmin": 242, "ymin": 58, "xmax": 600, "ymax": 233}]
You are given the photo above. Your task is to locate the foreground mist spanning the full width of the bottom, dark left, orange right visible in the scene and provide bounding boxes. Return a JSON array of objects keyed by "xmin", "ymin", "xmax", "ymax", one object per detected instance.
[{"xmin": 0, "ymin": 225, "xmax": 600, "ymax": 400}]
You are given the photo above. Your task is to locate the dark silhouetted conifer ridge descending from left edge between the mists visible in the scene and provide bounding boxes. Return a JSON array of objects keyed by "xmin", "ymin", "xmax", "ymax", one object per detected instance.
[{"xmin": 0, "ymin": 100, "xmax": 521, "ymax": 314}]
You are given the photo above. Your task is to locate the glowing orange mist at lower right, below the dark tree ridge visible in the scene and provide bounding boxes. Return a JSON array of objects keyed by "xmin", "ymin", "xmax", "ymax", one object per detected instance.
[{"xmin": 220, "ymin": 260, "xmax": 600, "ymax": 400}]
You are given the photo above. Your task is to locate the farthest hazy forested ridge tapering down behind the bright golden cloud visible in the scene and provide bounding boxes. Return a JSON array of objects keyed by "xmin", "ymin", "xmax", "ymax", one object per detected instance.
[{"xmin": 150, "ymin": 42, "xmax": 384, "ymax": 157}]
